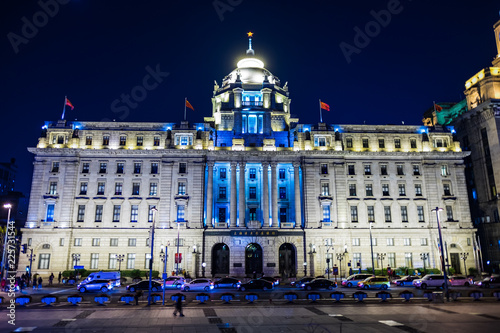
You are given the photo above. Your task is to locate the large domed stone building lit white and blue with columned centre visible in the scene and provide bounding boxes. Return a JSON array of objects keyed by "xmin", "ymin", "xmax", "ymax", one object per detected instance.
[{"xmin": 21, "ymin": 35, "xmax": 475, "ymax": 276}]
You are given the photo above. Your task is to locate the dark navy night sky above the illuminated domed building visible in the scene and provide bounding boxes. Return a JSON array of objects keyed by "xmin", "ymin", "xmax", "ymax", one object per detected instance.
[{"xmin": 0, "ymin": 0, "xmax": 500, "ymax": 194}]
